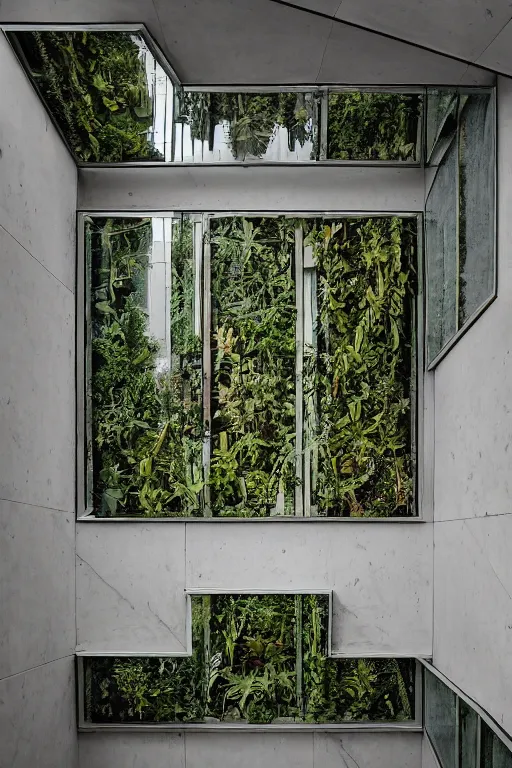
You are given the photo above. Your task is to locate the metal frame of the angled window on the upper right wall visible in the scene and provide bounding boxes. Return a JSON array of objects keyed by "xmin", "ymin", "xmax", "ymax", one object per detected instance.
[{"xmin": 424, "ymin": 86, "xmax": 499, "ymax": 371}]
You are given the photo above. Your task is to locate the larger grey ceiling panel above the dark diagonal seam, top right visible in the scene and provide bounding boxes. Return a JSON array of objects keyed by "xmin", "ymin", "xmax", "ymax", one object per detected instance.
[{"xmin": 277, "ymin": 0, "xmax": 512, "ymax": 62}]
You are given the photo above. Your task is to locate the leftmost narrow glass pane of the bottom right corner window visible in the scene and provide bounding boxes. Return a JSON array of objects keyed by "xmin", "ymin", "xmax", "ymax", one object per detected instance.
[{"xmin": 424, "ymin": 670, "xmax": 458, "ymax": 768}]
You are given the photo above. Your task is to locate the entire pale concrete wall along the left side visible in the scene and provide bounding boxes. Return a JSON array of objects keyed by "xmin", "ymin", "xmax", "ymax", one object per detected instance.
[{"xmin": 0, "ymin": 31, "xmax": 76, "ymax": 768}]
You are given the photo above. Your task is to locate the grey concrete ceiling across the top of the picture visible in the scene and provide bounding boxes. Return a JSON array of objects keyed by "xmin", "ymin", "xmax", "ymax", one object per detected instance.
[{"xmin": 0, "ymin": 0, "xmax": 500, "ymax": 85}]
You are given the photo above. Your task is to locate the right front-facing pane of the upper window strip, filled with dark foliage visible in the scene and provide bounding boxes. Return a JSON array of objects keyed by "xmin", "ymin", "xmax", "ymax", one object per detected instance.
[{"xmin": 327, "ymin": 92, "xmax": 421, "ymax": 161}]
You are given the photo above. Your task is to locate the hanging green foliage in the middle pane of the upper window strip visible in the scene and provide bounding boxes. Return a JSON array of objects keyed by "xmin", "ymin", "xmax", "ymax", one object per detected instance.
[{"xmin": 177, "ymin": 91, "xmax": 315, "ymax": 160}]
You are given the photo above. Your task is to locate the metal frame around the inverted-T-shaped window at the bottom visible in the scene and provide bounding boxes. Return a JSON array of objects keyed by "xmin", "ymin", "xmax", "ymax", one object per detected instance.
[{"xmin": 75, "ymin": 589, "xmax": 423, "ymax": 733}]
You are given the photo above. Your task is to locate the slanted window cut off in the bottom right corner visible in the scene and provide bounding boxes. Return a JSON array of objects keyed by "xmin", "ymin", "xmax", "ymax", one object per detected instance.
[{"xmin": 423, "ymin": 669, "xmax": 512, "ymax": 768}]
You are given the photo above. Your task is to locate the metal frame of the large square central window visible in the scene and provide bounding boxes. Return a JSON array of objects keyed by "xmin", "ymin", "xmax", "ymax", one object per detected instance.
[{"xmin": 76, "ymin": 211, "xmax": 429, "ymax": 524}]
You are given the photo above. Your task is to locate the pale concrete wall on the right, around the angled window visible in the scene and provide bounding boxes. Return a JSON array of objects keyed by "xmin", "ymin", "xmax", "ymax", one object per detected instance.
[{"xmin": 434, "ymin": 73, "xmax": 512, "ymax": 734}]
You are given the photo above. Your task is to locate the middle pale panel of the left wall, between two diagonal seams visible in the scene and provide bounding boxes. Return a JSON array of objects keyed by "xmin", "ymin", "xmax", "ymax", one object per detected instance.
[{"xmin": 0, "ymin": 228, "xmax": 75, "ymax": 511}]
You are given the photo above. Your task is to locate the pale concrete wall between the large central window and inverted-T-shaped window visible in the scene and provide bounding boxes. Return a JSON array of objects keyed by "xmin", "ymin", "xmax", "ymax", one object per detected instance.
[{"xmin": 77, "ymin": 520, "xmax": 432, "ymax": 656}]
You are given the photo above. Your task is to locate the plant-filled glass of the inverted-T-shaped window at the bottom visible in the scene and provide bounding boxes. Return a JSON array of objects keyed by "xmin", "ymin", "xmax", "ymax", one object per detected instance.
[{"xmin": 84, "ymin": 595, "xmax": 415, "ymax": 724}]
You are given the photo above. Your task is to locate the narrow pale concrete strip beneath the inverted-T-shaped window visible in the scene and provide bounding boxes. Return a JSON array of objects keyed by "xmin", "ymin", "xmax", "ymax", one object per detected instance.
[{"xmin": 79, "ymin": 732, "xmax": 422, "ymax": 768}]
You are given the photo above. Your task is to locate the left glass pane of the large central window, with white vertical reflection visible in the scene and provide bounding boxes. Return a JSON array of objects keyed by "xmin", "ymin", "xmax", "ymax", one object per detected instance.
[{"xmin": 85, "ymin": 218, "xmax": 203, "ymax": 517}]
